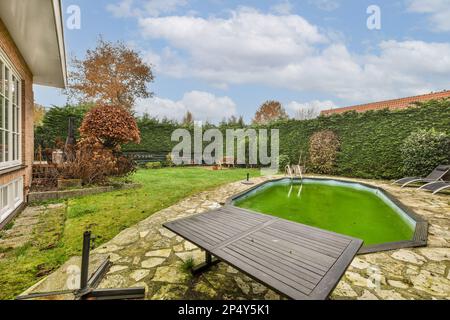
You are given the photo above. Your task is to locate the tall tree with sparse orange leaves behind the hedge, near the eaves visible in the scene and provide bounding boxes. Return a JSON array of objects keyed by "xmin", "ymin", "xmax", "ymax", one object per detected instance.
[{"xmin": 68, "ymin": 38, "xmax": 154, "ymax": 110}]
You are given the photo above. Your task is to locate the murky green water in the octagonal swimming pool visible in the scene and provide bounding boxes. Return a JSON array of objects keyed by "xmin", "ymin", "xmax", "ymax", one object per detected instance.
[{"xmin": 234, "ymin": 180, "xmax": 414, "ymax": 246}]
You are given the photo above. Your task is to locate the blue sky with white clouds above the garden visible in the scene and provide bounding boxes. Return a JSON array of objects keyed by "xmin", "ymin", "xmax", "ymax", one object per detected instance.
[{"xmin": 35, "ymin": 0, "xmax": 450, "ymax": 121}]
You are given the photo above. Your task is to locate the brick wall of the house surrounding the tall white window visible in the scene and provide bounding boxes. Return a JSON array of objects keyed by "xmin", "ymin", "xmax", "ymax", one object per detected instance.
[{"xmin": 0, "ymin": 19, "xmax": 34, "ymax": 198}]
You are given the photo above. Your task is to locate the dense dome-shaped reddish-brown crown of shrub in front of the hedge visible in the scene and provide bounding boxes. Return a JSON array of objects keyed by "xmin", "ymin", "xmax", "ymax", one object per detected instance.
[{"xmin": 80, "ymin": 105, "xmax": 140, "ymax": 149}]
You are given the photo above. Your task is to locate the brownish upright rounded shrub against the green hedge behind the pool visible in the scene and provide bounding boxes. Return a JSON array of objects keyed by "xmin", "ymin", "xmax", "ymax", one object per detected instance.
[{"xmin": 309, "ymin": 130, "xmax": 340, "ymax": 174}]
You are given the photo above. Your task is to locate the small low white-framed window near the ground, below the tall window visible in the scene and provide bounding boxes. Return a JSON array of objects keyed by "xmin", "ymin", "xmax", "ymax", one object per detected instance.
[{"xmin": 0, "ymin": 177, "xmax": 23, "ymax": 222}]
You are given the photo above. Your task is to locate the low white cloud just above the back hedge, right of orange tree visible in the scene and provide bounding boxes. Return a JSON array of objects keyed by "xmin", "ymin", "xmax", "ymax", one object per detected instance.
[{"xmin": 136, "ymin": 91, "xmax": 237, "ymax": 122}]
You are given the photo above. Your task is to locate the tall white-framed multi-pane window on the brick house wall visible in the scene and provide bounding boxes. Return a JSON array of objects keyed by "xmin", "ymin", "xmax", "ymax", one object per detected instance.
[{"xmin": 0, "ymin": 52, "xmax": 22, "ymax": 169}]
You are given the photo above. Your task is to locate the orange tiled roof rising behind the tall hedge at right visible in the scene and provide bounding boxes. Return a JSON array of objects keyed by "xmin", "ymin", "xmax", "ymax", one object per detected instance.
[{"xmin": 321, "ymin": 90, "xmax": 450, "ymax": 116}]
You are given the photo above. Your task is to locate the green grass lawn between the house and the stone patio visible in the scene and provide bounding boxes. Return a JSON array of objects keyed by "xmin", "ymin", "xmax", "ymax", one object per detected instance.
[{"xmin": 0, "ymin": 168, "xmax": 259, "ymax": 300}]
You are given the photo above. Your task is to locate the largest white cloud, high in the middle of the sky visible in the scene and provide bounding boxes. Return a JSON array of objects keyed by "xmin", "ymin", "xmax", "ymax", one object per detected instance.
[{"xmin": 140, "ymin": 8, "xmax": 327, "ymax": 86}]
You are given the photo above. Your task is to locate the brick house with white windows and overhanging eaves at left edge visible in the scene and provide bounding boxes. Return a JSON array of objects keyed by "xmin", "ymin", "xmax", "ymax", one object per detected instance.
[{"xmin": 0, "ymin": 0, "xmax": 67, "ymax": 229}]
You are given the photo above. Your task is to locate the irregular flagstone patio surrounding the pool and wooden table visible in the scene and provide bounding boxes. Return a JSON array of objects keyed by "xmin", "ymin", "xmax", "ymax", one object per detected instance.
[{"xmin": 22, "ymin": 178, "xmax": 450, "ymax": 300}]
